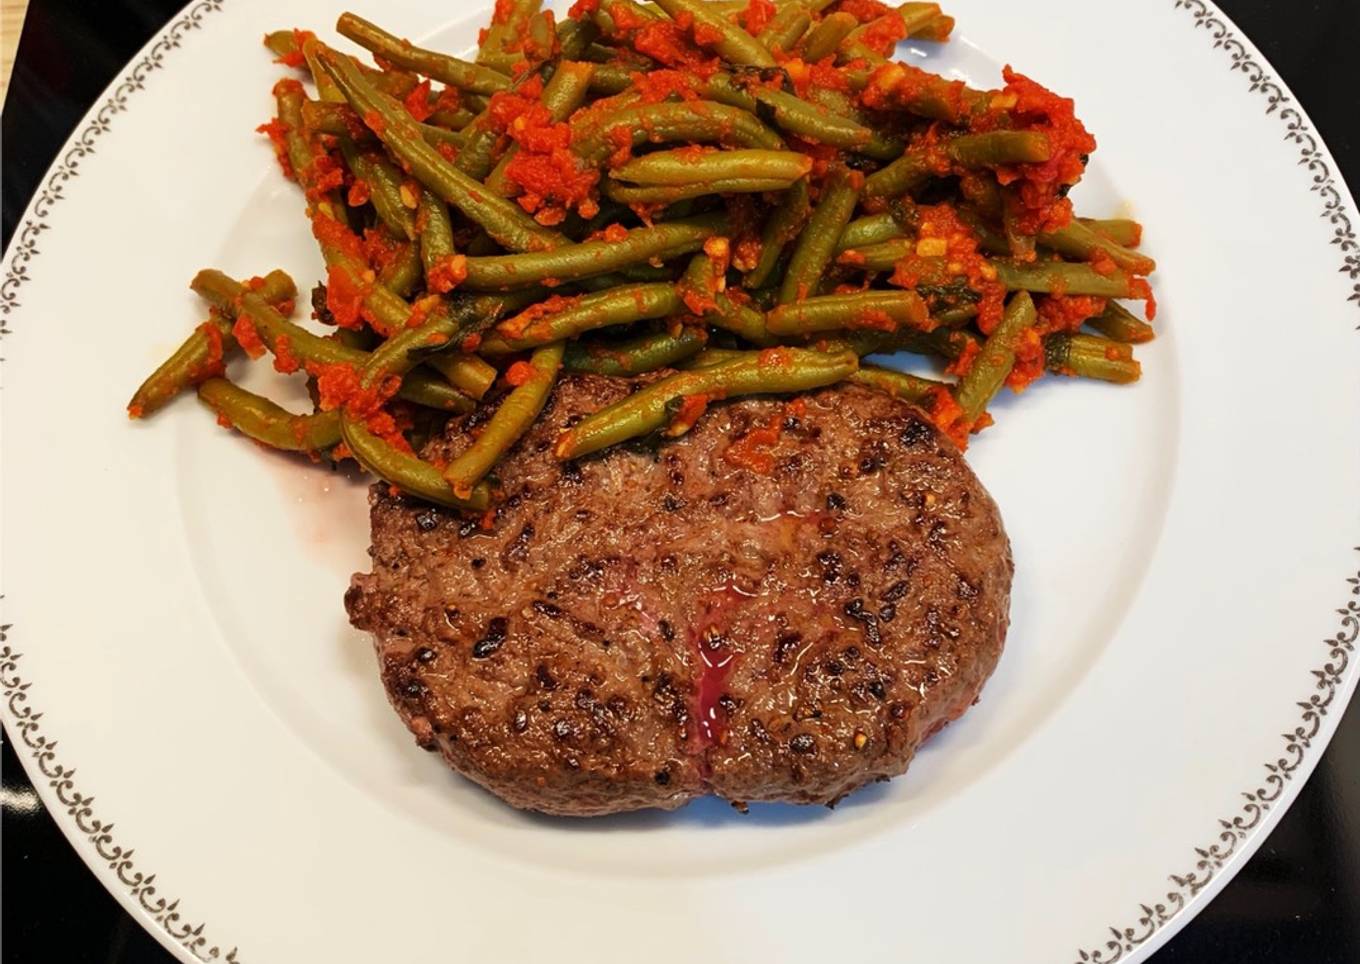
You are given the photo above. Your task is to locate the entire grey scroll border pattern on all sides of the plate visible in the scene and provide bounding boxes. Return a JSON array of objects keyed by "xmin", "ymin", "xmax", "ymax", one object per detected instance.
[{"xmin": 0, "ymin": 0, "xmax": 1360, "ymax": 964}]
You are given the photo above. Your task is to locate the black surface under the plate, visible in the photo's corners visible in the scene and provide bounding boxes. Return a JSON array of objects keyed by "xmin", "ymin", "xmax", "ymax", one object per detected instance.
[{"xmin": 0, "ymin": 0, "xmax": 1360, "ymax": 964}]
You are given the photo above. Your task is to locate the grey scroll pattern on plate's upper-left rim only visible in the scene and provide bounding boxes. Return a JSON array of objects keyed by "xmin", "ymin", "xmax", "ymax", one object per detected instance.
[{"xmin": 0, "ymin": 0, "xmax": 224, "ymax": 323}]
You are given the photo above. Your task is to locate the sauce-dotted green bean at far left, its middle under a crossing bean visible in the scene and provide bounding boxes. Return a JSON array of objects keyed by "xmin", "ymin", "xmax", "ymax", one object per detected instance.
[{"xmin": 189, "ymin": 269, "xmax": 472, "ymax": 412}]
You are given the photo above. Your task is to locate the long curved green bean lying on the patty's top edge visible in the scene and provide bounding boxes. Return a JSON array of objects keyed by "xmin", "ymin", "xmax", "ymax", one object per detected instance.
[{"xmin": 554, "ymin": 348, "xmax": 860, "ymax": 458}]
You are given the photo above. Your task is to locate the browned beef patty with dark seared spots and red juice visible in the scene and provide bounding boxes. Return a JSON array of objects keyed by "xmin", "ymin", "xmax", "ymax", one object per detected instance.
[{"xmin": 345, "ymin": 375, "xmax": 1013, "ymax": 816}]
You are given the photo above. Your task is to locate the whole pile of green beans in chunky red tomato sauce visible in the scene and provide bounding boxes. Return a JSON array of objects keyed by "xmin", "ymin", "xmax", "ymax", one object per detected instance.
[{"xmin": 128, "ymin": 0, "xmax": 1156, "ymax": 513}]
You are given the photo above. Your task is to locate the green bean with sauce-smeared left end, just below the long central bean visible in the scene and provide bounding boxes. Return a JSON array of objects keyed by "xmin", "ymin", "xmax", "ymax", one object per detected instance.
[{"xmin": 479, "ymin": 281, "xmax": 680, "ymax": 356}]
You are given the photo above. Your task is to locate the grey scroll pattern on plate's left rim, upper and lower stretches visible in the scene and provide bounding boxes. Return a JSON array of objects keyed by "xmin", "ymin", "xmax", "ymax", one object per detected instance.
[{"xmin": 0, "ymin": 0, "xmax": 241, "ymax": 964}]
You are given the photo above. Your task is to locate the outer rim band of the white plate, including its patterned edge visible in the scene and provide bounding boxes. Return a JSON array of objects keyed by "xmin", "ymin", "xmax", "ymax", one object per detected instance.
[{"xmin": 0, "ymin": 0, "xmax": 1360, "ymax": 964}]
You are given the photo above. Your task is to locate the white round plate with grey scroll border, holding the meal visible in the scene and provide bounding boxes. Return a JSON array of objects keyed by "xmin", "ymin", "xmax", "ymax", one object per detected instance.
[{"xmin": 0, "ymin": 0, "xmax": 1360, "ymax": 964}]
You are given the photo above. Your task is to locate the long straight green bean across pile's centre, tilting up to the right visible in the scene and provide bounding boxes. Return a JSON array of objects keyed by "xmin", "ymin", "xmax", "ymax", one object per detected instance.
[{"xmin": 462, "ymin": 215, "xmax": 728, "ymax": 291}]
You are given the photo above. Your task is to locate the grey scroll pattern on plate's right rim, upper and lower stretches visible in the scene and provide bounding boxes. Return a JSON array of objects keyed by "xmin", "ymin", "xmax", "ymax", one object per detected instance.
[{"xmin": 1076, "ymin": 0, "xmax": 1360, "ymax": 964}]
